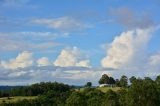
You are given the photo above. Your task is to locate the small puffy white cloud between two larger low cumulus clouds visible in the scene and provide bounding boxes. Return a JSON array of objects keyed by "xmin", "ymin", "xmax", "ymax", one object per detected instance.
[{"xmin": 37, "ymin": 57, "xmax": 51, "ymax": 66}]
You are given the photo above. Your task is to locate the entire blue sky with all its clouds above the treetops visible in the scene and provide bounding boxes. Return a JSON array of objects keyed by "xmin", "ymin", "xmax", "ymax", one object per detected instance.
[{"xmin": 0, "ymin": 0, "xmax": 160, "ymax": 85}]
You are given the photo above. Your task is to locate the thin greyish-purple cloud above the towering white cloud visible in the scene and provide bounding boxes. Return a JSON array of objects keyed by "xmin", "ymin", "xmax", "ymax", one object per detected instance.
[{"xmin": 110, "ymin": 7, "xmax": 155, "ymax": 28}]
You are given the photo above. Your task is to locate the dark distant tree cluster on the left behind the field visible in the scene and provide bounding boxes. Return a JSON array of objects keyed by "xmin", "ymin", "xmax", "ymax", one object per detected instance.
[{"xmin": 0, "ymin": 82, "xmax": 71, "ymax": 97}]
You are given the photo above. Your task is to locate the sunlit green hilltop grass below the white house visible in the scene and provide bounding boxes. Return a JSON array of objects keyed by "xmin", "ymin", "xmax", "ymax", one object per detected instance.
[{"xmin": 79, "ymin": 87, "xmax": 121, "ymax": 93}]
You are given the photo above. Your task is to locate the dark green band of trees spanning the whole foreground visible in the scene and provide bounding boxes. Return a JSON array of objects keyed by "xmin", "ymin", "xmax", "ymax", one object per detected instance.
[{"xmin": 2, "ymin": 74, "xmax": 160, "ymax": 106}]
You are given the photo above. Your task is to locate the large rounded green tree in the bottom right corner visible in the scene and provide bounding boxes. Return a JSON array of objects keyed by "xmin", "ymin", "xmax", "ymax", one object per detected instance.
[{"xmin": 126, "ymin": 79, "xmax": 159, "ymax": 106}]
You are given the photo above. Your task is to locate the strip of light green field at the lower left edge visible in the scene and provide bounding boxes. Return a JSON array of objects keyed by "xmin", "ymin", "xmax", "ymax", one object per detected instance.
[{"xmin": 0, "ymin": 96, "xmax": 37, "ymax": 104}]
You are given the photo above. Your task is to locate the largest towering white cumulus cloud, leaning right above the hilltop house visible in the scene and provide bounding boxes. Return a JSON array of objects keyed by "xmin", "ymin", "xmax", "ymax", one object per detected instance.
[{"xmin": 101, "ymin": 28, "xmax": 153, "ymax": 69}]
